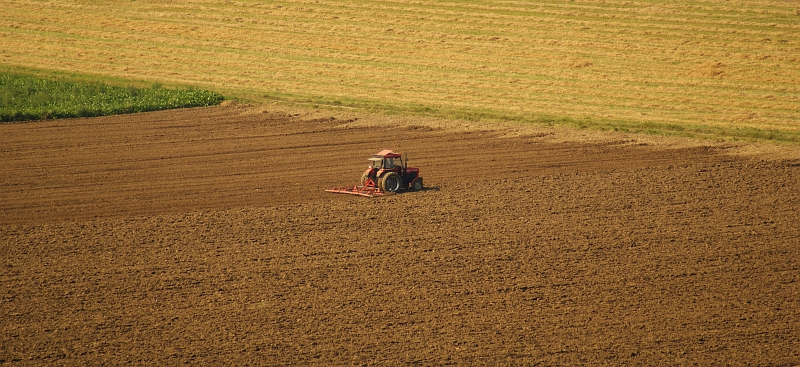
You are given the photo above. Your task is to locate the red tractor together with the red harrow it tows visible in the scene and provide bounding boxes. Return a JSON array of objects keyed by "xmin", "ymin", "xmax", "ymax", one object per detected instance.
[{"xmin": 325, "ymin": 150, "xmax": 422, "ymax": 197}]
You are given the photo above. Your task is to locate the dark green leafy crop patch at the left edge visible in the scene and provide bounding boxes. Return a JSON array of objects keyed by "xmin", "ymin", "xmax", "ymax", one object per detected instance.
[{"xmin": 0, "ymin": 72, "xmax": 225, "ymax": 122}]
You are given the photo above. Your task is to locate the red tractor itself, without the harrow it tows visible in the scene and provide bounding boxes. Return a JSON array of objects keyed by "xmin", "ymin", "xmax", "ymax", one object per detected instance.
[{"xmin": 361, "ymin": 150, "xmax": 422, "ymax": 192}]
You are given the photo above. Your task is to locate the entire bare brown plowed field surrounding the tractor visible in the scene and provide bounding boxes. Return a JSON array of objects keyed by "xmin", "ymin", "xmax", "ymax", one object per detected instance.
[{"xmin": 0, "ymin": 106, "xmax": 800, "ymax": 365}]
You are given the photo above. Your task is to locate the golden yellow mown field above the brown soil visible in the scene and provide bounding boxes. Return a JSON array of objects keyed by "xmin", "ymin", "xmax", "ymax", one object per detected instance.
[{"xmin": 0, "ymin": 0, "xmax": 800, "ymax": 142}]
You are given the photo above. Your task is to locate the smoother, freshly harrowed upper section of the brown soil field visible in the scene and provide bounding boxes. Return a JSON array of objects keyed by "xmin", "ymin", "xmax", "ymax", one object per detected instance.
[{"xmin": 0, "ymin": 102, "xmax": 702, "ymax": 223}]
